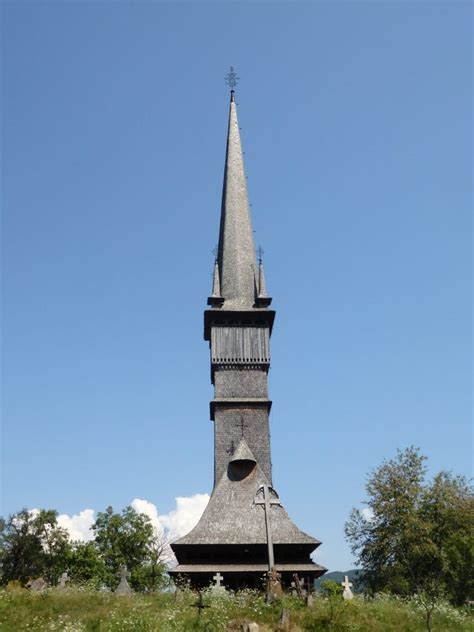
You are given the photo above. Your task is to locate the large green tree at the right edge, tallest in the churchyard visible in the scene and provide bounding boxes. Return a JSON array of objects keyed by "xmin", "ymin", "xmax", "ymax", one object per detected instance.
[{"xmin": 345, "ymin": 447, "xmax": 474, "ymax": 612}]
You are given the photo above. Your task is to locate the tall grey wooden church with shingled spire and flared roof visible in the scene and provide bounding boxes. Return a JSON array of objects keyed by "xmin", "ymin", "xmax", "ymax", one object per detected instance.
[{"xmin": 171, "ymin": 82, "xmax": 326, "ymax": 589}]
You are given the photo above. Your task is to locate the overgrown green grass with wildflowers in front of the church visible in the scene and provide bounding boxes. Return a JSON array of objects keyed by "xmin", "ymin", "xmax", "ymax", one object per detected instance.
[{"xmin": 0, "ymin": 589, "xmax": 474, "ymax": 632}]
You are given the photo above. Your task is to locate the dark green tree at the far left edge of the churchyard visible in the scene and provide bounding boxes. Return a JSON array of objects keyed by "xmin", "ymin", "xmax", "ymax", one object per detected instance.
[{"xmin": 0, "ymin": 509, "xmax": 70, "ymax": 584}]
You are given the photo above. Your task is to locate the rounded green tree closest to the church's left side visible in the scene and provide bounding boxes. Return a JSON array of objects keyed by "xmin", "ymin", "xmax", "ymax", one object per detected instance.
[{"xmin": 92, "ymin": 507, "xmax": 162, "ymax": 590}]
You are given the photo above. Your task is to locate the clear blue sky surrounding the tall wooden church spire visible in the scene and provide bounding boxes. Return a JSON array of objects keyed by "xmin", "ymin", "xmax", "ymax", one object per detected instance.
[{"xmin": 2, "ymin": 1, "xmax": 472, "ymax": 569}]
